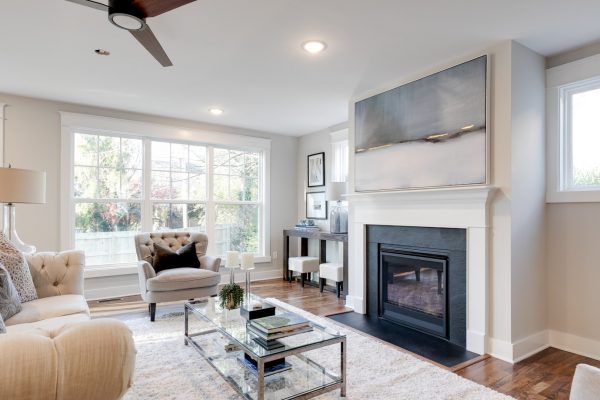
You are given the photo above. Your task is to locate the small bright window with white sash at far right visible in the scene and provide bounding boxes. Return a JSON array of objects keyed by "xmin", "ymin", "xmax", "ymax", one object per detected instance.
[{"xmin": 560, "ymin": 78, "xmax": 600, "ymax": 191}]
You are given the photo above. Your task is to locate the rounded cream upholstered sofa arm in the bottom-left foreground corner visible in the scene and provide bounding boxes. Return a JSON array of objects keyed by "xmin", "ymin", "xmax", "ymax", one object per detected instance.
[{"xmin": 0, "ymin": 318, "xmax": 136, "ymax": 400}]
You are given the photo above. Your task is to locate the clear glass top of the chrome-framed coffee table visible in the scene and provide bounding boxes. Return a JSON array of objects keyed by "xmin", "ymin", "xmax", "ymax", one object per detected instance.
[{"xmin": 186, "ymin": 296, "xmax": 343, "ymax": 357}]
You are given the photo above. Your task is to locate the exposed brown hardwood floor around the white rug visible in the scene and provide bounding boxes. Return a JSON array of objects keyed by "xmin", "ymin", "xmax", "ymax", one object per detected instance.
[{"xmin": 89, "ymin": 279, "xmax": 600, "ymax": 400}]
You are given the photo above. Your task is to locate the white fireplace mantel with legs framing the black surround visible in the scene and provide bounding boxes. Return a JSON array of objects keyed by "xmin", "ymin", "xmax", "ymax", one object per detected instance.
[{"xmin": 346, "ymin": 186, "xmax": 495, "ymax": 354}]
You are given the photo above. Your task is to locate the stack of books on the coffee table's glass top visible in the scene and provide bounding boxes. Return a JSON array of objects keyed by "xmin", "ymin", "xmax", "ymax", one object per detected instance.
[{"xmin": 248, "ymin": 312, "xmax": 312, "ymax": 350}]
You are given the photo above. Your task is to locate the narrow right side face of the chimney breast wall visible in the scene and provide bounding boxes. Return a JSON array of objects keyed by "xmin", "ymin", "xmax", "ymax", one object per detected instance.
[{"xmin": 511, "ymin": 42, "xmax": 547, "ymax": 359}]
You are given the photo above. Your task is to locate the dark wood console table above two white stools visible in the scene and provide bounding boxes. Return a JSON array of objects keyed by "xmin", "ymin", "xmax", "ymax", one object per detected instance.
[{"xmin": 283, "ymin": 229, "xmax": 348, "ymax": 296}]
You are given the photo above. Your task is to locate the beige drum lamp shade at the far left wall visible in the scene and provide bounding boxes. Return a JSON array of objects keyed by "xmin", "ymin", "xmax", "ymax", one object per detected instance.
[{"xmin": 0, "ymin": 167, "xmax": 46, "ymax": 204}]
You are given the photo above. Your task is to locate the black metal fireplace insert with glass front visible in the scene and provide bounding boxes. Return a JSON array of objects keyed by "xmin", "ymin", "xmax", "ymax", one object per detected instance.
[{"xmin": 378, "ymin": 245, "xmax": 448, "ymax": 338}]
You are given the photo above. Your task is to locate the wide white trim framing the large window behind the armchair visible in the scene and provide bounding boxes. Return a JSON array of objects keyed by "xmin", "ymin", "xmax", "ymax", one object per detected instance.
[{"xmin": 59, "ymin": 111, "xmax": 271, "ymax": 278}]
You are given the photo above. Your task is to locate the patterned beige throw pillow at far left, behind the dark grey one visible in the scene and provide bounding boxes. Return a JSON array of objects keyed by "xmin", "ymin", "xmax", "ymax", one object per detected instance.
[{"xmin": 0, "ymin": 233, "xmax": 37, "ymax": 302}]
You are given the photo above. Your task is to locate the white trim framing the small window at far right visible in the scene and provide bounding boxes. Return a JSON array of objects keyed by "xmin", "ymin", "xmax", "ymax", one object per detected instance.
[{"xmin": 546, "ymin": 55, "xmax": 600, "ymax": 203}]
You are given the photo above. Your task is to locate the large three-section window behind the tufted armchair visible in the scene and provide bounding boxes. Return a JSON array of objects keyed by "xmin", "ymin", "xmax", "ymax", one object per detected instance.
[{"xmin": 63, "ymin": 115, "xmax": 268, "ymax": 267}]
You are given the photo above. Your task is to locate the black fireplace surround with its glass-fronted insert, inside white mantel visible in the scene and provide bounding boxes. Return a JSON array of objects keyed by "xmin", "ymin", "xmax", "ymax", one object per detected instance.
[{"xmin": 367, "ymin": 225, "xmax": 467, "ymax": 347}]
